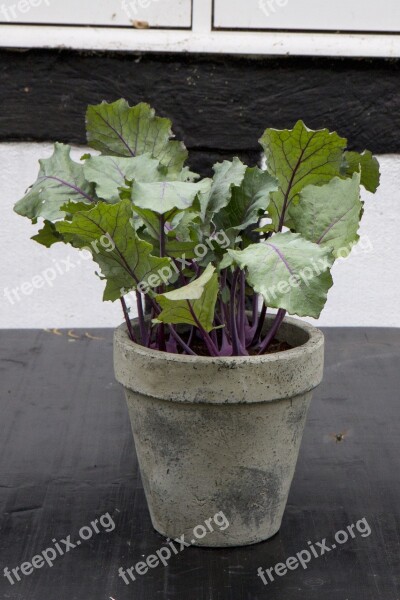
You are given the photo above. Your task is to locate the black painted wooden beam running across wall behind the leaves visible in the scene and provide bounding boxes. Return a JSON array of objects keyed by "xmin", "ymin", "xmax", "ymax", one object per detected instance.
[{"xmin": 0, "ymin": 50, "xmax": 400, "ymax": 173}]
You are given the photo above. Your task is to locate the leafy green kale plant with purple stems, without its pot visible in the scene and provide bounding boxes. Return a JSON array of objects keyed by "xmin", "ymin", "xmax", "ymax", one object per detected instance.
[{"xmin": 15, "ymin": 100, "xmax": 379, "ymax": 356}]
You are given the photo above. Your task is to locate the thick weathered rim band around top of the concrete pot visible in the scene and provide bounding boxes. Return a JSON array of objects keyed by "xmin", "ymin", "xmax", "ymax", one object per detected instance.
[{"xmin": 114, "ymin": 315, "xmax": 324, "ymax": 404}]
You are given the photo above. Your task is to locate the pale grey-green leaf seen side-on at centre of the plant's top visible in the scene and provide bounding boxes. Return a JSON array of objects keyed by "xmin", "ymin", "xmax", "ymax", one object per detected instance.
[{"xmin": 132, "ymin": 179, "xmax": 211, "ymax": 215}]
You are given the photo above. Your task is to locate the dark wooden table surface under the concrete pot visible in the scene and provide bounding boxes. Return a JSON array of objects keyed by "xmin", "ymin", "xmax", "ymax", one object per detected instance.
[{"xmin": 0, "ymin": 329, "xmax": 400, "ymax": 600}]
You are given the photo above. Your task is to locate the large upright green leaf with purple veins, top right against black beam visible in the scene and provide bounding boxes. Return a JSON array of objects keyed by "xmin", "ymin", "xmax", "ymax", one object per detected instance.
[{"xmin": 260, "ymin": 121, "xmax": 347, "ymax": 230}]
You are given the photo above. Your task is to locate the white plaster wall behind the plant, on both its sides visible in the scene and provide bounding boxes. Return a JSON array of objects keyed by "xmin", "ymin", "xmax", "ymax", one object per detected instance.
[{"xmin": 0, "ymin": 143, "xmax": 400, "ymax": 328}]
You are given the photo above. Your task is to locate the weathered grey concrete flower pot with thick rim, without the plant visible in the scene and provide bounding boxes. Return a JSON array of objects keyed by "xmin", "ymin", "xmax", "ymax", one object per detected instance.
[{"xmin": 114, "ymin": 318, "xmax": 324, "ymax": 546}]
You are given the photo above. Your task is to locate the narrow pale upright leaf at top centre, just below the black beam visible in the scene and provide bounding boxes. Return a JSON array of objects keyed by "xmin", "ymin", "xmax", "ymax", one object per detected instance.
[{"xmin": 200, "ymin": 157, "xmax": 247, "ymax": 220}]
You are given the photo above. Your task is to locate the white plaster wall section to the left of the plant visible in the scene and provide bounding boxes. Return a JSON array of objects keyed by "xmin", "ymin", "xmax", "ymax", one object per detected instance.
[{"xmin": 0, "ymin": 143, "xmax": 123, "ymax": 328}]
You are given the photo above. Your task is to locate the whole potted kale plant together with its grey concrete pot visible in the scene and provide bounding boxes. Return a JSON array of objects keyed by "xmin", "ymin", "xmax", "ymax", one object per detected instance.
[{"xmin": 15, "ymin": 100, "xmax": 379, "ymax": 546}]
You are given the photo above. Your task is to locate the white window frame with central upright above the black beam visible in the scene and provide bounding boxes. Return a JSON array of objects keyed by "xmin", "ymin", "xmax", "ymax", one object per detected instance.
[{"xmin": 0, "ymin": 0, "xmax": 400, "ymax": 58}]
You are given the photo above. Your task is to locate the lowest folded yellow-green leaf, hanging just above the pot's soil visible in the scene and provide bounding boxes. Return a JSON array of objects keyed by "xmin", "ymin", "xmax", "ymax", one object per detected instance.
[{"xmin": 156, "ymin": 264, "xmax": 218, "ymax": 331}]
